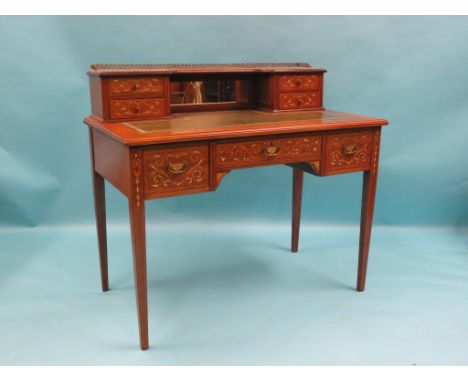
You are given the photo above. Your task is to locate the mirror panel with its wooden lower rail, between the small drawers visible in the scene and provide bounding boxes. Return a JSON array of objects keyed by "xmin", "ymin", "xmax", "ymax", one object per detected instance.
[{"xmin": 170, "ymin": 79, "xmax": 252, "ymax": 111}]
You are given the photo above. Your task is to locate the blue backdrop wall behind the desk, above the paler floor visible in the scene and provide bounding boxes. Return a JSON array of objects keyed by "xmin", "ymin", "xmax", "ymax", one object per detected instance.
[{"xmin": 0, "ymin": 17, "xmax": 468, "ymax": 226}]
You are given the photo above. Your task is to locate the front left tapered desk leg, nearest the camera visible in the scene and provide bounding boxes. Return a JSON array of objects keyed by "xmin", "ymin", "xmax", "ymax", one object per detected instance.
[{"xmin": 129, "ymin": 151, "xmax": 148, "ymax": 350}]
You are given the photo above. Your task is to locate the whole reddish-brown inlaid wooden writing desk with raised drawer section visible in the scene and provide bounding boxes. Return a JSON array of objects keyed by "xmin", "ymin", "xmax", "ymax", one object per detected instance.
[{"xmin": 85, "ymin": 63, "xmax": 388, "ymax": 350}]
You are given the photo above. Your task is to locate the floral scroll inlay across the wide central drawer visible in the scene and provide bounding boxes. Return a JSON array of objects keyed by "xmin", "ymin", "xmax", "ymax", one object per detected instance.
[{"xmin": 217, "ymin": 136, "xmax": 320, "ymax": 165}]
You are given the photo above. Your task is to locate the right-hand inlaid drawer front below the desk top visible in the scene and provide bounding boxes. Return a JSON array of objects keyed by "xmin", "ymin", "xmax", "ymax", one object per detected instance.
[{"xmin": 324, "ymin": 131, "xmax": 372, "ymax": 174}]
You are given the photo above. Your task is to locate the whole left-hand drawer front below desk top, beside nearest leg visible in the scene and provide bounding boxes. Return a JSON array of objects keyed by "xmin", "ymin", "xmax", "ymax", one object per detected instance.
[{"xmin": 143, "ymin": 145, "xmax": 210, "ymax": 196}]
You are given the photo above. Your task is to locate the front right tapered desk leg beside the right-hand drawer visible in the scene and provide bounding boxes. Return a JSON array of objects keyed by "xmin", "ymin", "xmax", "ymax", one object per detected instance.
[{"xmin": 356, "ymin": 128, "xmax": 380, "ymax": 292}]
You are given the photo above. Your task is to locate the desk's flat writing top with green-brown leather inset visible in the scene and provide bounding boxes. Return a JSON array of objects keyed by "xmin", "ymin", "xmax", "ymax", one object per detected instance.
[{"xmin": 85, "ymin": 110, "xmax": 388, "ymax": 146}]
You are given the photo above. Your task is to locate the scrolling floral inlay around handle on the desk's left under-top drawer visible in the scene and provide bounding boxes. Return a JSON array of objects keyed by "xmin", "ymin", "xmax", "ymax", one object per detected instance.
[{"xmin": 145, "ymin": 150, "xmax": 208, "ymax": 189}]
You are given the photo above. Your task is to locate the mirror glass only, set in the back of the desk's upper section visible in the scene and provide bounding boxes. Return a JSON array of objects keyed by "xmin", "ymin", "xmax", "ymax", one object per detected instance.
[{"xmin": 171, "ymin": 80, "xmax": 250, "ymax": 105}]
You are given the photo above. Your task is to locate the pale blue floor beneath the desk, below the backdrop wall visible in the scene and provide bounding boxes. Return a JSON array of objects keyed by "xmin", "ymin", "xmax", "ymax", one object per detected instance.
[{"xmin": 0, "ymin": 225, "xmax": 468, "ymax": 365}]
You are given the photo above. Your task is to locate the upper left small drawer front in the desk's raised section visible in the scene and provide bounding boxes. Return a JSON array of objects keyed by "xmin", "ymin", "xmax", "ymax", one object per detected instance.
[{"xmin": 109, "ymin": 77, "xmax": 164, "ymax": 96}]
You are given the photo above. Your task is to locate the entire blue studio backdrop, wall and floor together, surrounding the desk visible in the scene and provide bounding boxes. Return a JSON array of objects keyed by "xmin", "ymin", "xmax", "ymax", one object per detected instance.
[{"xmin": 0, "ymin": 16, "xmax": 468, "ymax": 365}]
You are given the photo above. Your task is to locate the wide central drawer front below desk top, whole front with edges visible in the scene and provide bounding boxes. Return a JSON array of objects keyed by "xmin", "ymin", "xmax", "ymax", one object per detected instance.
[{"xmin": 216, "ymin": 135, "xmax": 321, "ymax": 169}]
